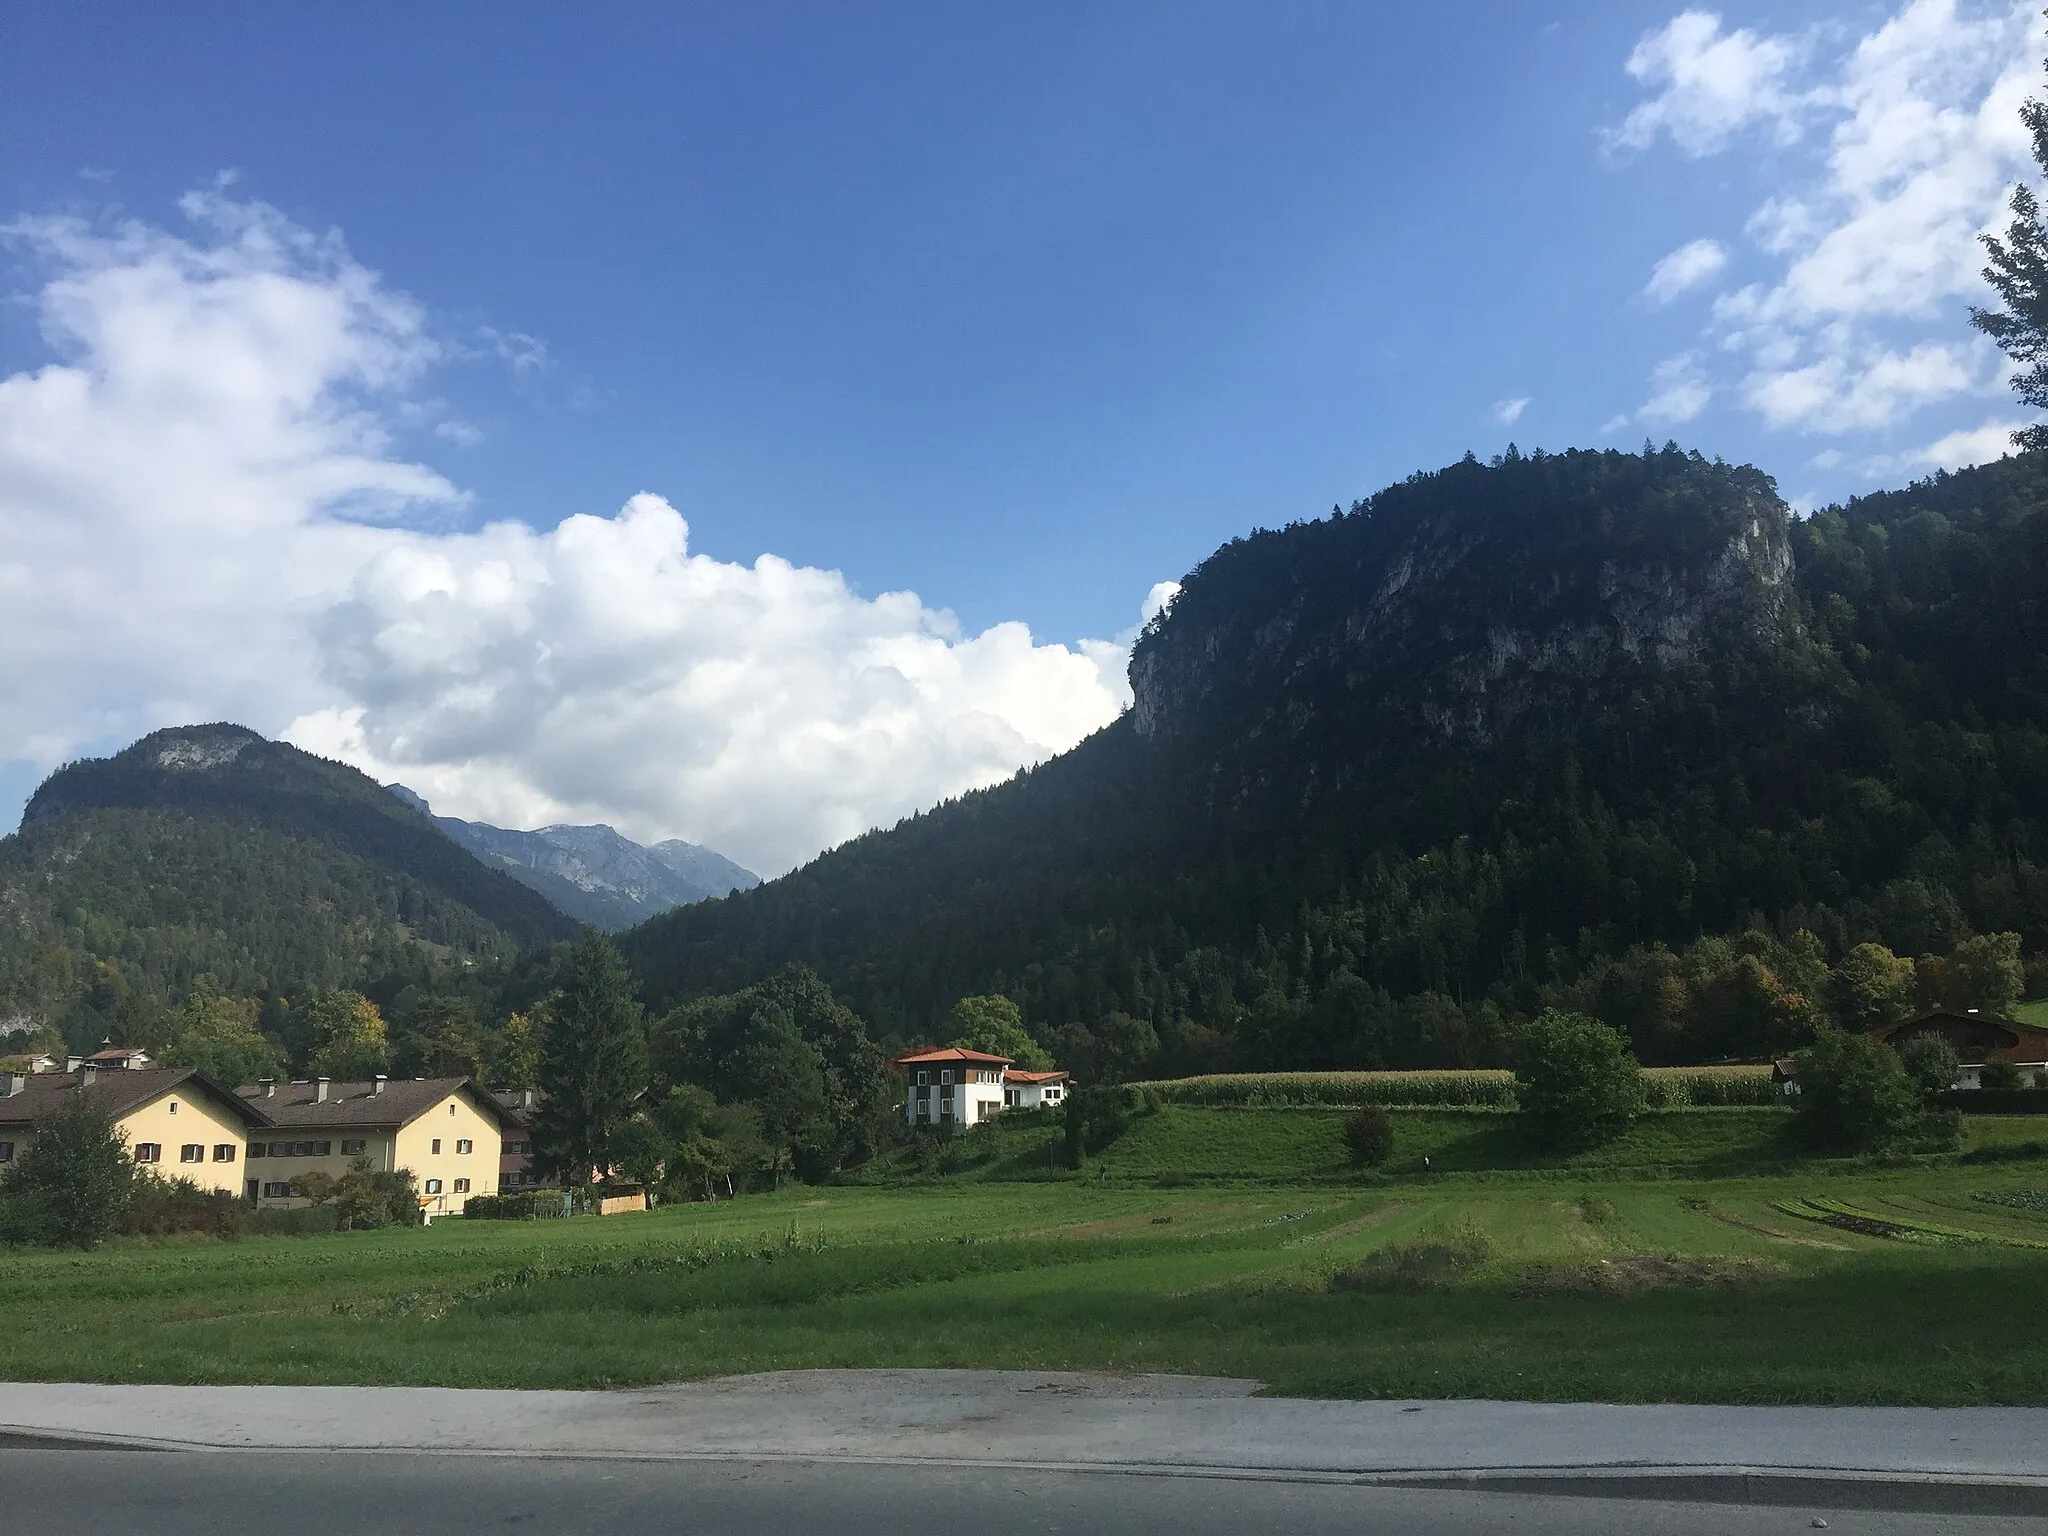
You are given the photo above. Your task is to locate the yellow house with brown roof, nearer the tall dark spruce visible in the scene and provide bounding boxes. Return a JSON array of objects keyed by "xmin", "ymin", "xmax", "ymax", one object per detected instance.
[{"xmin": 236, "ymin": 1077, "xmax": 506, "ymax": 1217}]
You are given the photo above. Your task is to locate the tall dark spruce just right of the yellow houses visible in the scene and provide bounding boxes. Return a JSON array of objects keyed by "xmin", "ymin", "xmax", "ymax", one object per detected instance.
[{"xmin": 532, "ymin": 930, "xmax": 647, "ymax": 1184}]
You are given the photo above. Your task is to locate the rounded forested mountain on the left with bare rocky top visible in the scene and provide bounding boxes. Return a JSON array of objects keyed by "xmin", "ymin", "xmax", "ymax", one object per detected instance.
[{"xmin": 0, "ymin": 725, "xmax": 578, "ymax": 1044}]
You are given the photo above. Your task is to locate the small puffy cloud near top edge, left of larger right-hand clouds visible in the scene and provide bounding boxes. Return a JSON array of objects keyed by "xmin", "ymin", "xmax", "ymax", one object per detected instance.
[{"xmin": 1608, "ymin": 10, "xmax": 1804, "ymax": 156}]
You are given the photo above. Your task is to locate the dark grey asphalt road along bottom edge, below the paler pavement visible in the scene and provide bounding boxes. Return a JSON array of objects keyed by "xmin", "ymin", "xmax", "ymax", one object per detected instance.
[{"xmin": 0, "ymin": 1448, "xmax": 2048, "ymax": 1536}]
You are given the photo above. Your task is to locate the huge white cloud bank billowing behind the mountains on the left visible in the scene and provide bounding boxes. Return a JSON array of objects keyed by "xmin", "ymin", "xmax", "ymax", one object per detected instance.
[{"xmin": 0, "ymin": 193, "xmax": 1169, "ymax": 872}]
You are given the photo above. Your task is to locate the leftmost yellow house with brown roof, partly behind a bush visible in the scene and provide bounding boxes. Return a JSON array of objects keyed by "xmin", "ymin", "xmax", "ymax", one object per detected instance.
[{"xmin": 0, "ymin": 1067, "xmax": 262, "ymax": 1192}]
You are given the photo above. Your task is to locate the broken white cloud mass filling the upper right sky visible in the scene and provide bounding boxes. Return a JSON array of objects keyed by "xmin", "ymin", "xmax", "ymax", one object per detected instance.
[{"xmin": 1618, "ymin": 0, "xmax": 2044, "ymax": 444}]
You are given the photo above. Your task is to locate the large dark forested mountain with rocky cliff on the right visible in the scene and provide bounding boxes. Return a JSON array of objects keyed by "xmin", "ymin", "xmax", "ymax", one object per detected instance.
[{"xmin": 623, "ymin": 446, "xmax": 2048, "ymax": 1071}]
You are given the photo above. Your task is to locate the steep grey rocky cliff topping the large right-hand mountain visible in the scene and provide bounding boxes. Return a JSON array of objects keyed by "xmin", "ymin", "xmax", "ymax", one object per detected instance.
[{"xmin": 1130, "ymin": 444, "xmax": 1798, "ymax": 757}]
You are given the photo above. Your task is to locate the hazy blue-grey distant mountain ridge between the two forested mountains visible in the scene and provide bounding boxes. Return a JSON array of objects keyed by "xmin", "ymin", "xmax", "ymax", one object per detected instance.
[{"xmin": 385, "ymin": 784, "xmax": 760, "ymax": 934}]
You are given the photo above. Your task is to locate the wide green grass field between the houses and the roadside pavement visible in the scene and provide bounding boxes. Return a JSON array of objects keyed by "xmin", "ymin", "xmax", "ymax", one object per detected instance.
[{"xmin": 0, "ymin": 1110, "xmax": 2048, "ymax": 1403}]
